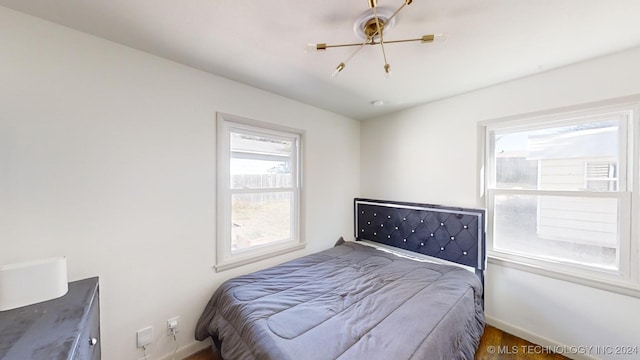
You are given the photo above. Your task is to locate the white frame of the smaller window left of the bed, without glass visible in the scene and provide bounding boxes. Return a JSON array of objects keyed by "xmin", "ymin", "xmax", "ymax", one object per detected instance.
[{"xmin": 215, "ymin": 113, "xmax": 306, "ymax": 271}]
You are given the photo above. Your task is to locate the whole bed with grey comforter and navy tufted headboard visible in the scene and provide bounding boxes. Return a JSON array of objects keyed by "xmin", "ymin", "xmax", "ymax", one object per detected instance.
[{"xmin": 195, "ymin": 199, "xmax": 486, "ymax": 360}]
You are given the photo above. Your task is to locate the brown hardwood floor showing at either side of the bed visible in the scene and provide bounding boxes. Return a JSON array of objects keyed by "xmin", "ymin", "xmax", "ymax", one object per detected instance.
[{"xmin": 185, "ymin": 325, "xmax": 568, "ymax": 360}]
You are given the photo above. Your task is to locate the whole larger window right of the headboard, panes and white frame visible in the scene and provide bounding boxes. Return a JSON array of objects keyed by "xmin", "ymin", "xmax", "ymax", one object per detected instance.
[{"xmin": 482, "ymin": 98, "xmax": 640, "ymax": 296}]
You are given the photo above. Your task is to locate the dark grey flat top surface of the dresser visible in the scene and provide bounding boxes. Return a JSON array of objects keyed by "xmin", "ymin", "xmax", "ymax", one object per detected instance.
[{"xmin": 0, "ymin": 277, "xmax": 98, "ymax": 359}]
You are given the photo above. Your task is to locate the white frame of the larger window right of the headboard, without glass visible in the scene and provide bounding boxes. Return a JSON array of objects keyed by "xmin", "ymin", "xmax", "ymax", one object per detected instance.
[{"xmin": 478, "ymin": 96, "xmax": 640, "ymax": 297}]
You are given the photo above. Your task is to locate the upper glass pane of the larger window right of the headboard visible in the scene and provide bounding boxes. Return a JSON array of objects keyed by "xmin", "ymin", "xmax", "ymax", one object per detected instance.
[{"xmin": 494, "ymin": 120, "xmax": 620, "ymax": 191}]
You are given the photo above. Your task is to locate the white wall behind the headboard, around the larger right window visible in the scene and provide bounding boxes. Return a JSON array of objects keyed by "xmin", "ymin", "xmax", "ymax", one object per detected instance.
[{"xmin": 361, "ymin": 48, "xmax": 640, "ymax": 359}]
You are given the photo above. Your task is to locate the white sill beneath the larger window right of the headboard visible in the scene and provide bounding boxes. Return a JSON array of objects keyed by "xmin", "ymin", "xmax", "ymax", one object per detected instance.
[{"xmin": 487, "ymin": 251, "xmax": 640, "ymax": 298}]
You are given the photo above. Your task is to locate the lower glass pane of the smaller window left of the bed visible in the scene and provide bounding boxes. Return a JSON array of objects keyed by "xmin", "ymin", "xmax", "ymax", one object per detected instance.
[{"xmin": 231, "ymin": 192, "xmax": 294, "ymax": 253}]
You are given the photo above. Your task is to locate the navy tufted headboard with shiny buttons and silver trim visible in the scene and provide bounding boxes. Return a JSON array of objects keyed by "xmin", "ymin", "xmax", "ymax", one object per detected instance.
[{"xmin": 354, "ymin": 198, "xmax": 486, "ymax": 283}]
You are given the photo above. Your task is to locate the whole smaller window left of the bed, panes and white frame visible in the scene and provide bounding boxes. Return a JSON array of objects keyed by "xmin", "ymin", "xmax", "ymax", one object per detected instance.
[{"xmin": 216, "ymin": 114, "xmax": 304, "ymax": 270}]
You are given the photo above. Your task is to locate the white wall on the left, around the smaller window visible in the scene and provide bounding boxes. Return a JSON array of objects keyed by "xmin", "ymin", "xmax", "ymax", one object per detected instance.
[{"xmin": 0, "ymin": 7, "xmax": 360, "ymax": 360}]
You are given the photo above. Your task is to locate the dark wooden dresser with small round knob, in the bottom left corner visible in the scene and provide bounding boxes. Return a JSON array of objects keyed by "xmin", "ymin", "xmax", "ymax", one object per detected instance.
[{"xmin": 0, "ymin": 277, "xmax": 100, "ymax": 360}]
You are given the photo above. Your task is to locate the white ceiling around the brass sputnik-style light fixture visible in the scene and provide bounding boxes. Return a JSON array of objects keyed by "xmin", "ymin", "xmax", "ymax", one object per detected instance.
[{"xmin": 0, "ymin": 0, "xmax": 640, "ymax": 119}]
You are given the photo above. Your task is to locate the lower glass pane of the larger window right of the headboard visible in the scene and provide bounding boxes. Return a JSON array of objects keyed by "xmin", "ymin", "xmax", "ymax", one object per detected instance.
[{"xmin": 493, "ymin": 195, "xmax": 618, "ymax": 270}]
